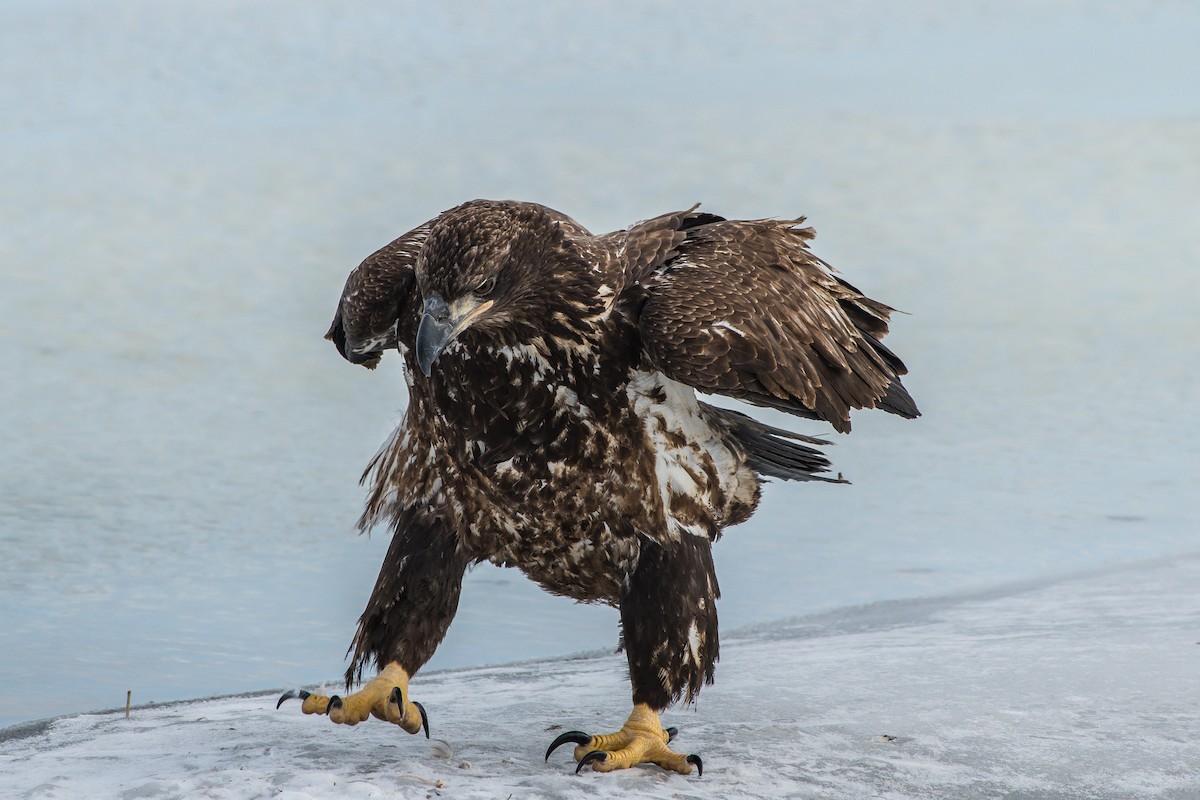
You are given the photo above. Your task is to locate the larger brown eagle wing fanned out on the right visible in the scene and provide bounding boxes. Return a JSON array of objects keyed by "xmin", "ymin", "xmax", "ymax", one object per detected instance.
[{"xmin": 630, "ymin": 218, "xmax": 919, "ymax": 432}]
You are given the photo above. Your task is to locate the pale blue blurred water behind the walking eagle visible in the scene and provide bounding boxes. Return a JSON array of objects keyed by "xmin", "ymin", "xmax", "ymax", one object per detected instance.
[{"xmin": 0, "ymin": 2, "xmax": 1200, "ymax": 724}]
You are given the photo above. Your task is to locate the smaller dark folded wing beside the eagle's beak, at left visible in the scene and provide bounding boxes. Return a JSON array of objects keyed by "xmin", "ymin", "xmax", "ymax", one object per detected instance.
[{"xmin": 325, "ymin": 221, "xmax": 433, "ymax": 369}]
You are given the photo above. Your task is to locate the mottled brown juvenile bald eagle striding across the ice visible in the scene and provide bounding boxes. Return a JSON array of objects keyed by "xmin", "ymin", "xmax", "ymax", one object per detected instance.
[{"xmin": 280, "ymin": 200, "xmax": 918, "ymax": 774}]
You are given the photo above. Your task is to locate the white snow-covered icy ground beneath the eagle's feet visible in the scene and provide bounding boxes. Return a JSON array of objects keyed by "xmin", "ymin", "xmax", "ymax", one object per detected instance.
[{"xmin": 0, "ymin": 554, "xmax": 1200, "ymax": 800}]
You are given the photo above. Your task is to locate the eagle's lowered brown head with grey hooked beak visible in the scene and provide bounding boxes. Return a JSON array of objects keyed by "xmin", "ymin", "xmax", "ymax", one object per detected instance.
[{"xmin": 415, "ymin": 200, "xmax": 598, "ymax": 377}]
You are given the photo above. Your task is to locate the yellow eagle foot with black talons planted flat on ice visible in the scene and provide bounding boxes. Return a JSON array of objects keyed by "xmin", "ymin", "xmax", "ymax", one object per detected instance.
[{"xmin": 546, "ymin": 703, "xmax": 704, "ymax": 776}]
